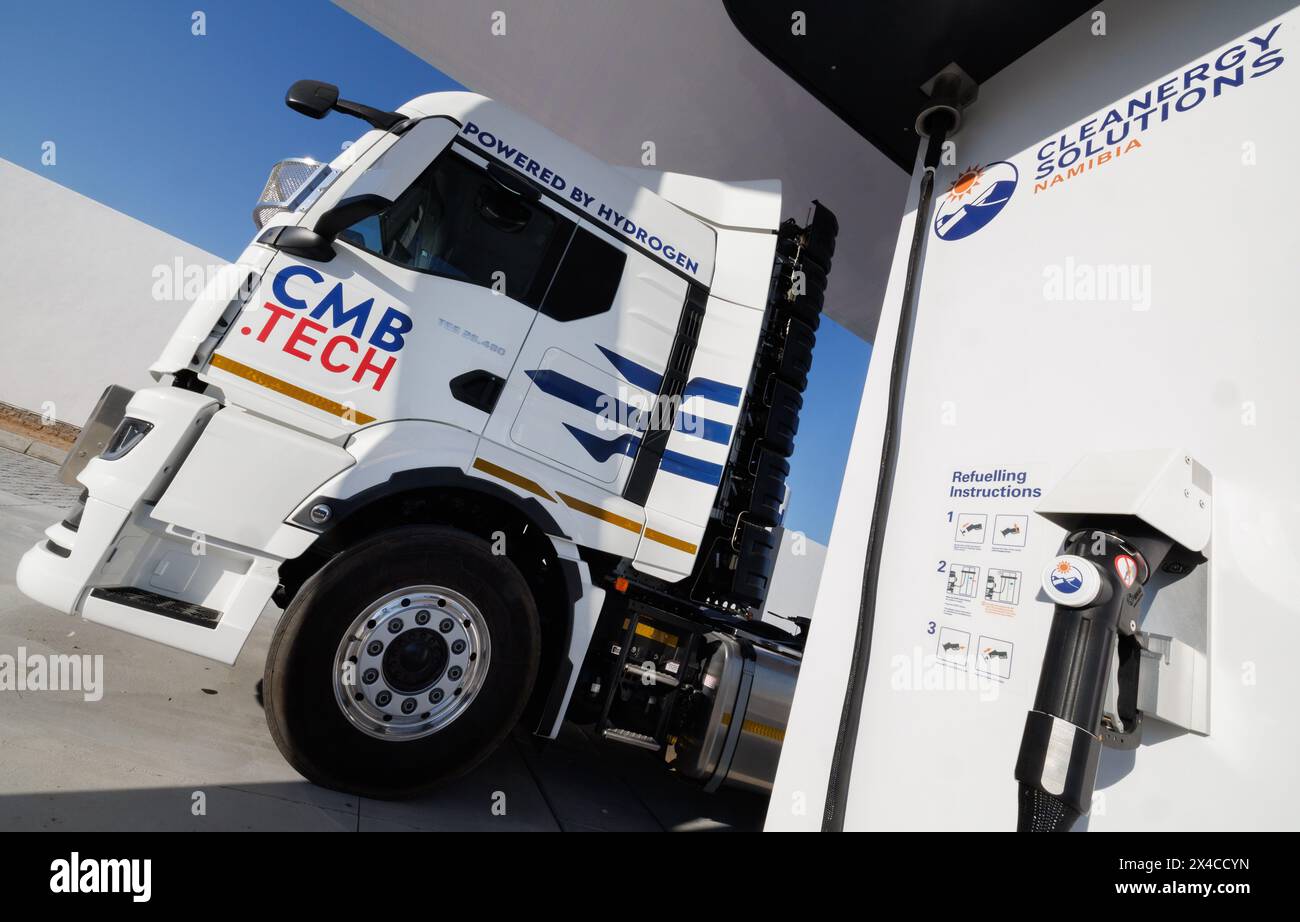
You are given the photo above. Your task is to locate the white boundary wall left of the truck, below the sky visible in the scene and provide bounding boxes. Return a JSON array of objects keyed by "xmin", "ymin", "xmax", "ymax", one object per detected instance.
[{"xmin": 0, "ymin": 160, "xmax": 222, "ymax": 425}]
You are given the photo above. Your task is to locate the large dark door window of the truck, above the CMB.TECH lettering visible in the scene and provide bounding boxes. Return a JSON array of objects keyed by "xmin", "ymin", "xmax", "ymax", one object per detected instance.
[{"xmin": 339, "ymin": 151, "xmax": 573, "ymax": 307}]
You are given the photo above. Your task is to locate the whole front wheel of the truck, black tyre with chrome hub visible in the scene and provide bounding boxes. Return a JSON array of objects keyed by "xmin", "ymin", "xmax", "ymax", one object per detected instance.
[{"xmin": 264, "ymin": 527, "xmax": 541, "ymax": 798}]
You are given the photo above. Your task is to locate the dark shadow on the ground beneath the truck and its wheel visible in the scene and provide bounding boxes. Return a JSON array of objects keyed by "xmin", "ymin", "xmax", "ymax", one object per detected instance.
[{"xmin": 0, "ymin": 724, "xmax": 766, "ymax": 832}]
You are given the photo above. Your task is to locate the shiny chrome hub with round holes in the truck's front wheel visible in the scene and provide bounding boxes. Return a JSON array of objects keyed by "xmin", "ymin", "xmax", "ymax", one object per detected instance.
[{"xmin": 334, "ymin": 585, "xmax": 491, "ymax": 740}]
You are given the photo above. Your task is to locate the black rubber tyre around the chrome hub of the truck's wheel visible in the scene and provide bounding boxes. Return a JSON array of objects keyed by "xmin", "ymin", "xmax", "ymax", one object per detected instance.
[{"xmin": 264, "ymin": 525, "xmax": 541, "ymax": 798}]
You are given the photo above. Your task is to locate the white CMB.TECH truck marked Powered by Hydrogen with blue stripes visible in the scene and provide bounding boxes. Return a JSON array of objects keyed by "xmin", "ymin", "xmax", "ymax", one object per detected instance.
[{"xmin": 18, "ymin": 81, "xmax": 837, "ymax": 797}]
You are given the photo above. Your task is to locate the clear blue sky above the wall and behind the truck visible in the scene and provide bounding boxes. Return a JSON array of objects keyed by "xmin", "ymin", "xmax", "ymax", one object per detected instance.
[{"xmin": 0, "ymin": 0, "xmax": 871, "ymax": 542}]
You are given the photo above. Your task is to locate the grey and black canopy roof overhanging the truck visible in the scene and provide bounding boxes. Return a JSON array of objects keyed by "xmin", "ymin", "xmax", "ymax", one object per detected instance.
[{"xmin": 340, "ymin": 0, "xmax": 1087, "ymax": 339}]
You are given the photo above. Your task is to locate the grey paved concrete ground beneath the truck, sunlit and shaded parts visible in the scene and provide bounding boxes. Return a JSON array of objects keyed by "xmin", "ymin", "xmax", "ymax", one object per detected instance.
[{"xmin": 0, "ymin": 449, "xmax": 766, "ymax": 831}]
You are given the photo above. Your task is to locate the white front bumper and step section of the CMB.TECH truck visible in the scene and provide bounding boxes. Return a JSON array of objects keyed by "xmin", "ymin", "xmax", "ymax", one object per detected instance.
[{"xmin": 17, "ymin": 386, "xmax": 327, "ymax": 663}]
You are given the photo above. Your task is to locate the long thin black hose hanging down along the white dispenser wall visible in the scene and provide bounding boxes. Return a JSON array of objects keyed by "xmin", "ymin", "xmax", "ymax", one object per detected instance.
[{"xmin": 822, "ymin": 109, "xmax": 954, "ymax": 832}]
